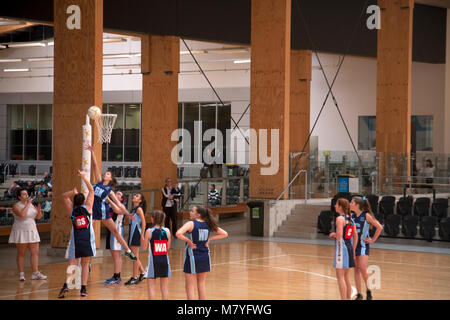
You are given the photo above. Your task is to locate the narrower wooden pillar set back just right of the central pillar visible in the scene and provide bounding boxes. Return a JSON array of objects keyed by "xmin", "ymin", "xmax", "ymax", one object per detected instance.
[{"xmin": 289, "ymin": 50, "xmax": 312, "ymax": 199}]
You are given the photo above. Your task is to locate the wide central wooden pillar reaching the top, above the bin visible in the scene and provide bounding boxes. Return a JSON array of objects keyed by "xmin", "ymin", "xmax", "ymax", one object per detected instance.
[{"xmin": 249, "ymin": 0, "xmax": 291, "ymax": 199}]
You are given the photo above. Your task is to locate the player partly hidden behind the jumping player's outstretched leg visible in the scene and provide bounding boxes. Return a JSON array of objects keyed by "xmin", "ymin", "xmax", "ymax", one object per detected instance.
[{"xmin": 104, "ymin": 191, "xmax": 125, "ymax": 284}]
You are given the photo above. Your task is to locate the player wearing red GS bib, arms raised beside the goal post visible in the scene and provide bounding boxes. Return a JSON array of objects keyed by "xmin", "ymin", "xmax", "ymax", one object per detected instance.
[{"xmin": 58, "ymin": 171, "xmax": 95, "ymax": 298}]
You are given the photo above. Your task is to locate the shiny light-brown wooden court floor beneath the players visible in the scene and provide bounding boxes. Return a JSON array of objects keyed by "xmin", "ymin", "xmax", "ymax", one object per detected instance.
[{"xmin": 0, "ymin": 241, "xmax": 450, "ymax": 300}]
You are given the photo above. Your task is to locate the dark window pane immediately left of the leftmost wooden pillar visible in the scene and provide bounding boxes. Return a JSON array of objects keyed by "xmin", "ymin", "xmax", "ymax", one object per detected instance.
[{"xmin": 39, "ymin": 104, "xmax": 53, "ymax": 160}]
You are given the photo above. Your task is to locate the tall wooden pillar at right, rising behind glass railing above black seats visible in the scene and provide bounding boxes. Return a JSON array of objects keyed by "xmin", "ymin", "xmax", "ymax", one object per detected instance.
[{"xmin": 376, "ymin": 0, "xmax": 414, "ymax": 188}]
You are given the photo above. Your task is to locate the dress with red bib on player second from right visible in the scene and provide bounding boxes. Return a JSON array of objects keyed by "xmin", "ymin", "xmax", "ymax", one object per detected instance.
[{"xmin": 333, "ymin": 214, "xmax": 355, "ymax": 269}]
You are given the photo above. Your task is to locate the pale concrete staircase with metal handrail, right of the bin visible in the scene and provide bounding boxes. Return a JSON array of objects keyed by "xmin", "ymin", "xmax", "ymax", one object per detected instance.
[{"xmin": 273, "ymin": 204, "xmax": 330, "ymax": 239}]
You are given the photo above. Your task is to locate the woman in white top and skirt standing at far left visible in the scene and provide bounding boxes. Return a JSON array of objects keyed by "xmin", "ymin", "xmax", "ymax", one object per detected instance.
[{"xmin": 9, "ymin": 188, "xmax": 47, "ymax": 281}]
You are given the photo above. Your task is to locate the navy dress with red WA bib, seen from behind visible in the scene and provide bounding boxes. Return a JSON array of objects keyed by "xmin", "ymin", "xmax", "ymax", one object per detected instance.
[{"xmin": 146, "ymin": 227, "xmax": 170, "ymax": 279}]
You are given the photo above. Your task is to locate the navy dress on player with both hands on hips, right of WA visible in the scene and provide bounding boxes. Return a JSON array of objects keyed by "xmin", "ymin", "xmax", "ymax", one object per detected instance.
[{"xmin": 183, "ymin": 220, "xmax": 211, "ymax": 274}]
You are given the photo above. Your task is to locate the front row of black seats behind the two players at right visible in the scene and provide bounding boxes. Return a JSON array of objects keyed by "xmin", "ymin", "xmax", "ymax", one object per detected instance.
[{"xmin": 317, "ymin": 211, "xmax": 450, "ymax": 241}]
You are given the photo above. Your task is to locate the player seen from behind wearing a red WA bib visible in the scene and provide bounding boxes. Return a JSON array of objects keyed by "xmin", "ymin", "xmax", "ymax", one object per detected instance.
[{"xmin": 142, "ymin": 210, "xmax": 171, "ymax": 300}]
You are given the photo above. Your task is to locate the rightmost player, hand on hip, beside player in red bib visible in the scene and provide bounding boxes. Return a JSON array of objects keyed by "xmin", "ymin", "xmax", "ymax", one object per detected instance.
[{"xmin": 350, "ymin": 197, "xmax": 383, "ymax": 300}]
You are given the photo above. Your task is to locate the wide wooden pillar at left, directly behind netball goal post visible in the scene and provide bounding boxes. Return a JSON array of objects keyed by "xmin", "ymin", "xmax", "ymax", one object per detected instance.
[{"xmin": 51, "ymin": 0, "xmax": 103, "ymax": 248}]
